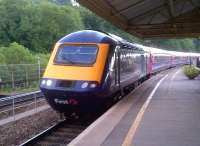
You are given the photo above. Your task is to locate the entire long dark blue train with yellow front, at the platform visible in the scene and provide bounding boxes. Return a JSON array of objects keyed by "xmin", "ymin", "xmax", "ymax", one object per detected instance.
[{"xmin": 40, "ymin": 30, "xmax": 200, "ymax": 116}]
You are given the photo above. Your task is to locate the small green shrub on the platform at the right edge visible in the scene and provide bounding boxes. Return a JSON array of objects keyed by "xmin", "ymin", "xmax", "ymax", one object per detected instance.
[{"xmin": 184, "ymin": 65, "xmax": 200, "ymax": 79}]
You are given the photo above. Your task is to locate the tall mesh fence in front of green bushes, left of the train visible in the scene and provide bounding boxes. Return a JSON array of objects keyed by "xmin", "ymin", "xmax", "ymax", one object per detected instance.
[{"xmin": 0, "ymin": 61, "xmax": 45, "ymax": 90}]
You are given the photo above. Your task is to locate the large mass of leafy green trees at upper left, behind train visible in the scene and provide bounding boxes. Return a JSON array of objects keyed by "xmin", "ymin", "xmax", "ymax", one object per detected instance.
[{"xmin": 0, "ymin": 0, "xmax": 84, "ymax": 52}]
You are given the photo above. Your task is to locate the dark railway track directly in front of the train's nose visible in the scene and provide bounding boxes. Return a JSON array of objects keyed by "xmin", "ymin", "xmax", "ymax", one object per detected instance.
[{"xmin": 19, "ymin": 120, "xmax": 93, "ymax": 146}]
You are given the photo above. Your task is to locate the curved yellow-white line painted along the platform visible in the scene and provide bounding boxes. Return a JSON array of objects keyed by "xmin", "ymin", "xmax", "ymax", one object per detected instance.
[{"xmin": 122, "ymin": 74, "xmax": 168, "ymax": 146}]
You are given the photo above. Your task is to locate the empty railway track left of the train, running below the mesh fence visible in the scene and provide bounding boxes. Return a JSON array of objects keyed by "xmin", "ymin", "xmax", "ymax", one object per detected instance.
[{"xmin": 0, "ymin": 91, "xmax": 44, "ymax": 109}]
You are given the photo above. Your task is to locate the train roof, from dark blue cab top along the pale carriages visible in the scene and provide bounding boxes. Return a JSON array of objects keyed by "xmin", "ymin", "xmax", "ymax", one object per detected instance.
[{"xmin": 58, "ymin": 30, "xmax": 200, "ymax": 56}]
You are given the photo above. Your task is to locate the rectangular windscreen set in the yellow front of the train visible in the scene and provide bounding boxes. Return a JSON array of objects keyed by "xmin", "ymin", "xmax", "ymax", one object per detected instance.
[{"xmin": 54, "ymin": 45, "xmax": 98, "ymax": 65}]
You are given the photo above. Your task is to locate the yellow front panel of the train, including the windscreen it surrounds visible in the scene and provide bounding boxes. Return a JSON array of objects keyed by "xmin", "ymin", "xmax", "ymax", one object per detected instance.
[{"xmin": 43, "ymin": 43, "xmax": 108, "ymax": 84}]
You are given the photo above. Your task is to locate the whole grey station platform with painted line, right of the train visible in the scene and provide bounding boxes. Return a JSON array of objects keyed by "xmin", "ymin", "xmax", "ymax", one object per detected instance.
[{"xmin": 69, "ymin": 68, "xmax": 200, "ymax": 146}]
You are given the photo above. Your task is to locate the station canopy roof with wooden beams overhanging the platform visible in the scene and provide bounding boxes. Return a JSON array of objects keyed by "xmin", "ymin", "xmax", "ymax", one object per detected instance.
[{"xmin": 78, "ymin": 0, "xmax": 200, "ymax": 38}]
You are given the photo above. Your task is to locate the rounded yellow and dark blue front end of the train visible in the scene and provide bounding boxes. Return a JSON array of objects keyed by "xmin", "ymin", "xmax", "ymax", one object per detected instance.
[{"xmin": 40, "ymin": 31, "xmax": 115, "ymax": 114}]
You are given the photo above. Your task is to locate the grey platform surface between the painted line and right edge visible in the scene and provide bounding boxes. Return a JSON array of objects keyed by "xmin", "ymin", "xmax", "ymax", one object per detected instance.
[{"xmin": 132, "ymin": 68, "xmax": 200, "ymax": 146}]
